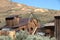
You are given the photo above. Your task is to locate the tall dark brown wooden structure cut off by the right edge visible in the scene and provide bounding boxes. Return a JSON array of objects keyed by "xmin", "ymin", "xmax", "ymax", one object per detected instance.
[{"xmin": 55, "ymin": 16, "xmax": 60, "ymax": 40}]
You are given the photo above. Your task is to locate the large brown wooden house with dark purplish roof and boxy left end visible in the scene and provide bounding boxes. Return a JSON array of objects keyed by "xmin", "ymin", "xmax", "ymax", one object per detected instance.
[{"xmin": 2, "ymin": 15, "xmax": 40, "ymax": 34}]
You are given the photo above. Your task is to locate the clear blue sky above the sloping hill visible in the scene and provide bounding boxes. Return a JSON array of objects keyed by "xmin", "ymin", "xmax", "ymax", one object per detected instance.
[{"xmin": 12, "ymin": 0, "xmax": 60, "ymax": 10}]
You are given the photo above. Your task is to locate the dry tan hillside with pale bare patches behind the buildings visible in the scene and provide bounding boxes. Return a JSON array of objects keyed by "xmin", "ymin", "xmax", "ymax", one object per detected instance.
[{"xmin": 0, "ymin": 0, "xmax": 60, "ymax": 26}]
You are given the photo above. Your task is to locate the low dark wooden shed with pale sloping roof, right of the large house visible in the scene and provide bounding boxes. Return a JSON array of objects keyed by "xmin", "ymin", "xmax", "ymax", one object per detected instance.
[{"xmin": 39, "ymin": 22, "xmax": 55, "ymax": 35}]
